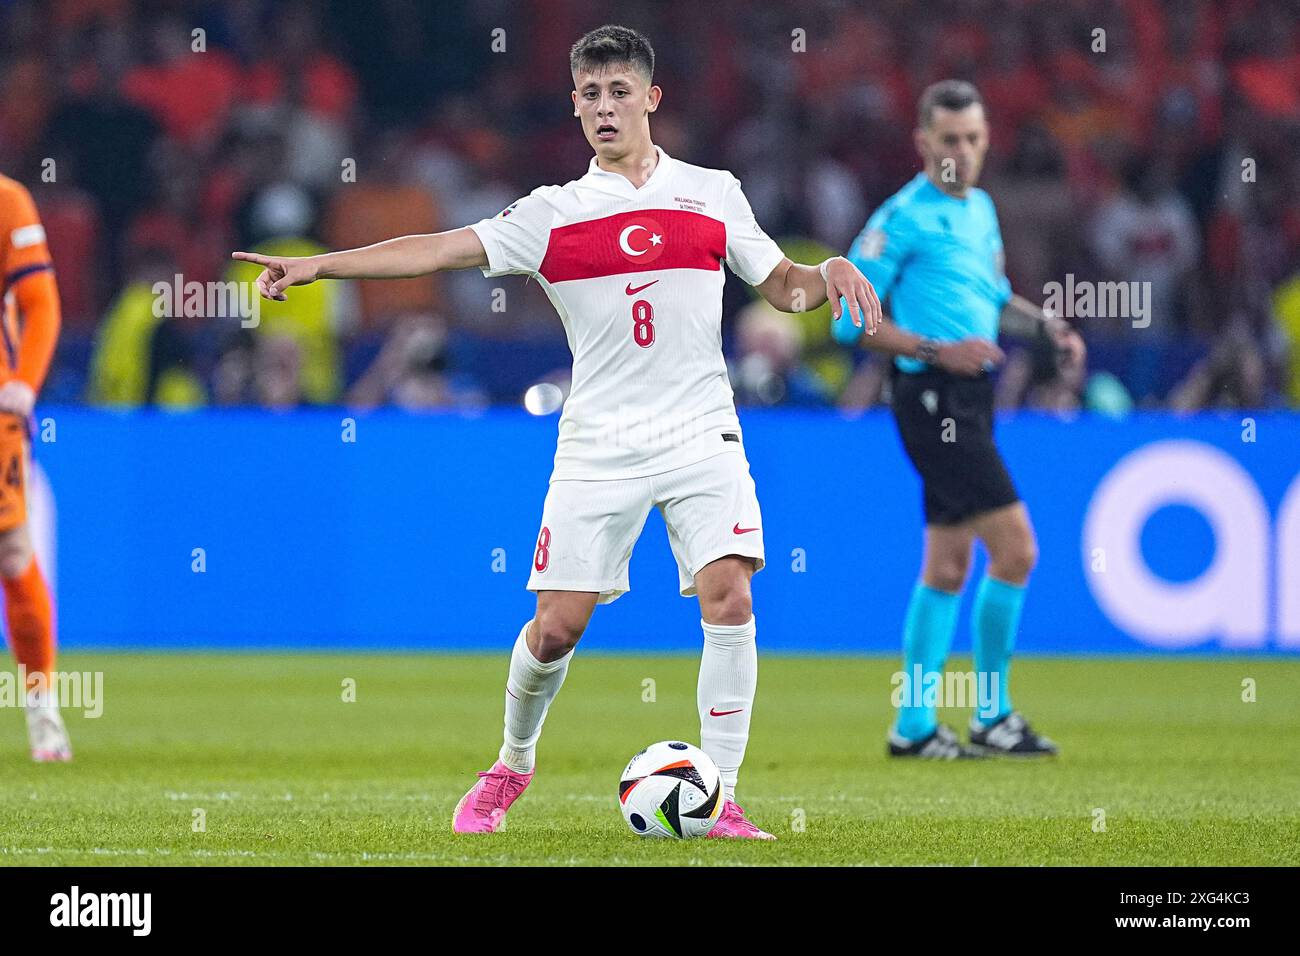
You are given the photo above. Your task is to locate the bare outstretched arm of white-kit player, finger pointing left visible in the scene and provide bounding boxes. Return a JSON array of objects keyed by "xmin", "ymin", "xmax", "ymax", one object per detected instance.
[{"xmin": 230, "ymin": 226, "xmax": 488, "ymax": 302}]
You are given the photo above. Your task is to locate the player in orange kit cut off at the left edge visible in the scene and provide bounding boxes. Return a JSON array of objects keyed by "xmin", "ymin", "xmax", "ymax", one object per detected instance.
[{"xmin": 0, "ymin": 176, "xmax": 73, "ymax": 762}]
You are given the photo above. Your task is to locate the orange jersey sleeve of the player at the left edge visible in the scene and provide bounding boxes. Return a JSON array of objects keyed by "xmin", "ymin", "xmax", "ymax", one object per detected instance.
[{"xmin": 0, "ymin": 176, "xmax": 61, "ymax": 392}]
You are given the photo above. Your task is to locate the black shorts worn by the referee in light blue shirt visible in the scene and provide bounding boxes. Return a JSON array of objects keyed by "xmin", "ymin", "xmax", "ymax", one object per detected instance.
[{"xmin": 892, "ymin": 365, "xmax": 1021, "ymax": 524}]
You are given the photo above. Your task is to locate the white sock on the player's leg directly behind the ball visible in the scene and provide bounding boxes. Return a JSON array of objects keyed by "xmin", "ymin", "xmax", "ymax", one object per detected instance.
[{"xmin": 696, "ymin": 617, "xmax": 758, "ymax": 800}]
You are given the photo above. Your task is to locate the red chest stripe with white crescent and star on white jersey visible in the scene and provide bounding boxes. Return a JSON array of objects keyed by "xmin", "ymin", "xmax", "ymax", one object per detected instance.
[{"xmin": 538, "ymin": 209, "xmax": 727, "ymax": 282}]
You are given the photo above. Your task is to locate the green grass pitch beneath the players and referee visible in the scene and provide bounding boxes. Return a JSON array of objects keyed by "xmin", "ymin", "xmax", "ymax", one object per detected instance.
[{"xmin": 0, "ymin": 650, "xmax": 1300, "ymax": 866}]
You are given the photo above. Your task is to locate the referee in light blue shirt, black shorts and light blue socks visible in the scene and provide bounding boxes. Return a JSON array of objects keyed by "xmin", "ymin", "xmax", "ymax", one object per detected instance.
[{"xmin": 832, "ymin": 79, "xmax": 1084, "ymax": 760}]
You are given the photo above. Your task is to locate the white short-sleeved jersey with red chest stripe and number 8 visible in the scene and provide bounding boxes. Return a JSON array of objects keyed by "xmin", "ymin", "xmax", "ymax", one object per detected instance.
[{"xmin": 471, "ymin": 147, "xmax": 784, "ymax": 481}]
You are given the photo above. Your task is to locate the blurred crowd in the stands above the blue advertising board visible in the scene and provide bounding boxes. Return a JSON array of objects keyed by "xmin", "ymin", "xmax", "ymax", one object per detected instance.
[{"xmin": 0, "ymin": 0, "xmax": 1300, "ymax": 414}]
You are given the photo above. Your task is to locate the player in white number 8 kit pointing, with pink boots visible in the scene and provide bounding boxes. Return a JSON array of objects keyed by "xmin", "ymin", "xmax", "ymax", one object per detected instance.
[{"xmin": 234, "ymin": 26, "xmax": 880, "ymax": 839}]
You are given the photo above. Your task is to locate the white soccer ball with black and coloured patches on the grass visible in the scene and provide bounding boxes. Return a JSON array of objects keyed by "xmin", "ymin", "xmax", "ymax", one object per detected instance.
[{"xmin": 619, "ymin": 740, "xmax": 725, "ymax": 840}]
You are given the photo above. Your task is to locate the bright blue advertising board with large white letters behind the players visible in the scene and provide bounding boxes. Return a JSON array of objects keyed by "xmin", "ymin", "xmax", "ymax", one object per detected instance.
[{"xmin": 35, "ymin": 408, "xmax": 1300, "ymax": 653}]
